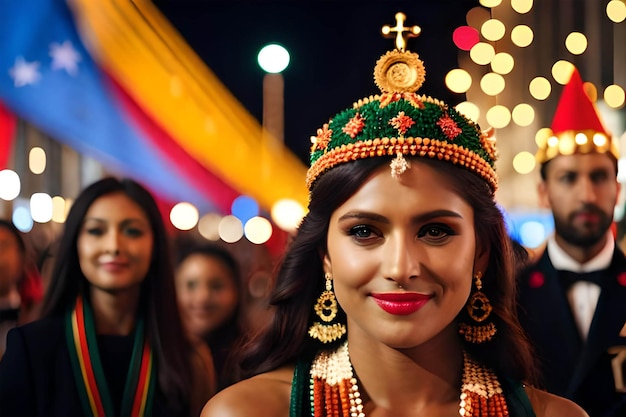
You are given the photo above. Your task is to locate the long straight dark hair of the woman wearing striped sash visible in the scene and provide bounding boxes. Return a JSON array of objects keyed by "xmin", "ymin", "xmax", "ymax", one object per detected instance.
[{"xmin": 42, "ymin": 177, "xmax": 192, "ymax": 413}]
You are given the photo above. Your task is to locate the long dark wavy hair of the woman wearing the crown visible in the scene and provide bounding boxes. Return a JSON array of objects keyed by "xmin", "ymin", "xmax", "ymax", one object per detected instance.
[{"xmin": 240, "ymin": 157, "xmax": 536, "ymax": 382}]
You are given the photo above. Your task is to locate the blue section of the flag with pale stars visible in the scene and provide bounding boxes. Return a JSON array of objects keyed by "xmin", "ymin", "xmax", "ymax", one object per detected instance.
[{"xmin": 0, "ymin": 0, "xmax": 224, "ymax": 212}]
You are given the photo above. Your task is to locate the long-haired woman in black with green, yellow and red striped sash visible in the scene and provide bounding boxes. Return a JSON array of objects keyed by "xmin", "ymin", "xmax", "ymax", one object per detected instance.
[{"xmin": 0, "ymin": 178, "xmax": 215, "ymax": 416}]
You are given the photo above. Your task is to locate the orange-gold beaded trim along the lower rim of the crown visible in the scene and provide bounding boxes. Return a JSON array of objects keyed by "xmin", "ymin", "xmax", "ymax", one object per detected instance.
[{"xmin": 306, "ymin": 137, "xmax": 498, "ymax": 193}]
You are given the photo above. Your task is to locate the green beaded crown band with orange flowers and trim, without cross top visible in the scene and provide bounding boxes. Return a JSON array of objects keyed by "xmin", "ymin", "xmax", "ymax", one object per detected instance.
[{"xmin": 307, "ymin": 92, "xmax": 497, "ymax": 191}]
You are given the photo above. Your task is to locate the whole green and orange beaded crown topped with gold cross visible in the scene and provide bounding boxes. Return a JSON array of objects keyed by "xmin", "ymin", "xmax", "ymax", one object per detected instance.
[{"xmin": 306, "ymin": 13, "xmax": 498, "ymax": 194}]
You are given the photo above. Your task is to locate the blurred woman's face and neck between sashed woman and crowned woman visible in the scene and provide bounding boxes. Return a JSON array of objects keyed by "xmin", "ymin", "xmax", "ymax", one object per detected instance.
[{"xmin": 176, "ymin": 243, "xmax": 244, "ymax": 389}]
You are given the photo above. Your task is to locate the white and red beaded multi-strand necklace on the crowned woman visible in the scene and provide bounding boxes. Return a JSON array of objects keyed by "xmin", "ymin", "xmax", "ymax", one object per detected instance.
[{"xmin": 310, "ymin": 342, "xmax": 509, "ymax": 417}]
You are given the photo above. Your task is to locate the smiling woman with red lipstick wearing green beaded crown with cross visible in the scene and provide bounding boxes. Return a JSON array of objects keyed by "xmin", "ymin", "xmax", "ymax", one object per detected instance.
[{"xmin": 202, "ymin": 14, "xmax": 586, "ymax": 417}]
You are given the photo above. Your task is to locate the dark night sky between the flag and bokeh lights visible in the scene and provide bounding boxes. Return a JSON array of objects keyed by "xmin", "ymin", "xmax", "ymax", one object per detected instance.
[{"xmin": 154, "ymin": 0, "xmax": 478, "ymax": 164}]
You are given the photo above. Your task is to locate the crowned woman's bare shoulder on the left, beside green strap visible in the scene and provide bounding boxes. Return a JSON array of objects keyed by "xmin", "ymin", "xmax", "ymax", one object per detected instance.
[{"xmin": 200, "ymin": 367, "xmax": 293, "ymax": 417}]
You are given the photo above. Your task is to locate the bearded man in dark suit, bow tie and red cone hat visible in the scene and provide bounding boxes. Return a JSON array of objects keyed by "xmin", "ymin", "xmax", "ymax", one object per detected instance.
[{"xmin": 518, "ymin": 70, "xmax": 626, "ymax": 417}]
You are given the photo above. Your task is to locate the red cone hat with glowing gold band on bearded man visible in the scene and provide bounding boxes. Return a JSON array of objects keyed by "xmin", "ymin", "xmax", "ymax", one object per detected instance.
[{"xmin": 535, "ymin": 68, "xmax": 619, "ymax": 164}]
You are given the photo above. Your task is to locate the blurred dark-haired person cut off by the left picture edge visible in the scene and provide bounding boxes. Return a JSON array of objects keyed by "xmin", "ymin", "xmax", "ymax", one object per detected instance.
[{"xmin": 0, "ymin": 219, "xmax": 43, "ymax": 358}]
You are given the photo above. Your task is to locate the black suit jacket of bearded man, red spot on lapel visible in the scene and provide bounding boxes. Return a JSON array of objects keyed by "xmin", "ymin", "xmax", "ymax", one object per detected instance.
[{"xmin": 518, "ymin": 246, "xmax": 626, "ymax": 417}]
